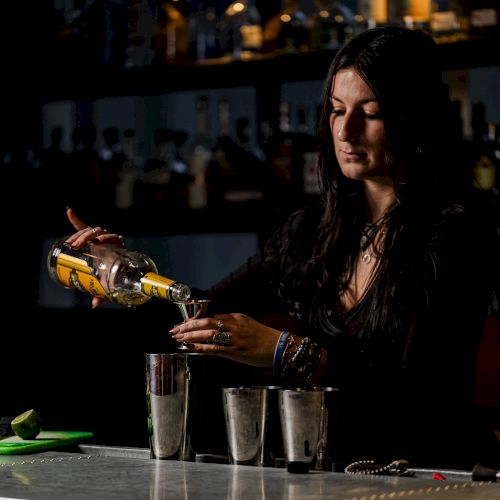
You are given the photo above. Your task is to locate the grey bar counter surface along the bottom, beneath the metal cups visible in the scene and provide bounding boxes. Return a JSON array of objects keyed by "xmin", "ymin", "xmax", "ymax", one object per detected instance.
[{"xmin": 0, "ymin": 445, "xmax": 500, "ymax": 500}]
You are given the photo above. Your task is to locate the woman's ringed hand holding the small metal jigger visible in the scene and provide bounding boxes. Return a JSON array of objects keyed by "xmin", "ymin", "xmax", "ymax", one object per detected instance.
[{"xmin": 170, "ymin": 313, "xmax": 281, "ymax": 367}]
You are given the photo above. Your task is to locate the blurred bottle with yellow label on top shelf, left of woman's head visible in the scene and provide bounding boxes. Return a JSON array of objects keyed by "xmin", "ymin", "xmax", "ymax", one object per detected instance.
[{"xmin": 221, "ymin": 0, "xmax": 263, "ymax": 59}]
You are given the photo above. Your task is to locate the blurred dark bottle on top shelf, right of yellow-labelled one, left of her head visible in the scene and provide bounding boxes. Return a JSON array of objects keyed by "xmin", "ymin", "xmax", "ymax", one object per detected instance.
[{"xmin": 264, "ymin": 0, "xmax": 310, "ymax": 53}]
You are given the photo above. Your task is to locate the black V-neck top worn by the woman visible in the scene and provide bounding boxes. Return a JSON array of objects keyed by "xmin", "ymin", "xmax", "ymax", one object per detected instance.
[{"xmin": 205, "ymin": 206, "xmax": 500, "ymax": 470}]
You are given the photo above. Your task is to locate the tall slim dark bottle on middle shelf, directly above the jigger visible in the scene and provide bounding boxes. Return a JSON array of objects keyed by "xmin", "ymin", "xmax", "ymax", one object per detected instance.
[{"xmin": 186, "ymin": 95, "xmax": 213, "ymax": 209}]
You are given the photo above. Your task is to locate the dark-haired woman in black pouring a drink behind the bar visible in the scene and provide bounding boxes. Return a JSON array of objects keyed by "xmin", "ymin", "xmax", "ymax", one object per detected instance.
[{"xmin": 68, "ymin": 27, "xmax": 500, "ymax": 469}]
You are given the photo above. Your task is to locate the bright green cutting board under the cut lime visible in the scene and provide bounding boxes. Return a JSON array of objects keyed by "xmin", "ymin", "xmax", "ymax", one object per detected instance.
[{"xmin": 0, "ymin": 431, "xmax": 94, "ymax": 455}]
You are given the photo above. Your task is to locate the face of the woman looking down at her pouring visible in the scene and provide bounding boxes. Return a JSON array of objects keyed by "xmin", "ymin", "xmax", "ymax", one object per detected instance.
[{"xmin": 330, "ymin": 68, "xmax": 389, "ymax": 181}]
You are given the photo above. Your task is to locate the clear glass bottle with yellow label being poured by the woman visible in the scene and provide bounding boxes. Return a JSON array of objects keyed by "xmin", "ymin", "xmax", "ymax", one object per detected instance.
[{"xmin": 47, "ymin": 237, "xmax": 191, "ymax": 306}]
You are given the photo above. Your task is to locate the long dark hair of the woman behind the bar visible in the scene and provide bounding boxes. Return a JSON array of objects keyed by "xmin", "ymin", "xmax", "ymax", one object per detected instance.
[{"xmin": 302, "ymin": 27, "xmax": 466, "ymax": 335}]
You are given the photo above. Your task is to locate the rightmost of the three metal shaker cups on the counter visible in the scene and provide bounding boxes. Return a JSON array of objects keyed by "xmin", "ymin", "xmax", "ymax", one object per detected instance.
[{"xmin": 278, "ymin": 387, "xmax": 334, "ymax": 472}]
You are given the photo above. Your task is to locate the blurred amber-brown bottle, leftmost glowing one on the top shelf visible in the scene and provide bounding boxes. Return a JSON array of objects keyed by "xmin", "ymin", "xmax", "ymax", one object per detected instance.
[{"xmin": 151, "ymin": 0, "xmax": 188, "ymax": 64}]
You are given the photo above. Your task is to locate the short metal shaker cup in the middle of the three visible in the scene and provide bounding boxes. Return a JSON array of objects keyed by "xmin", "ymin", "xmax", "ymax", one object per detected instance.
[{"xmin": 222, "ymin": 387, "xmax": 270, "ymax": 466}]
